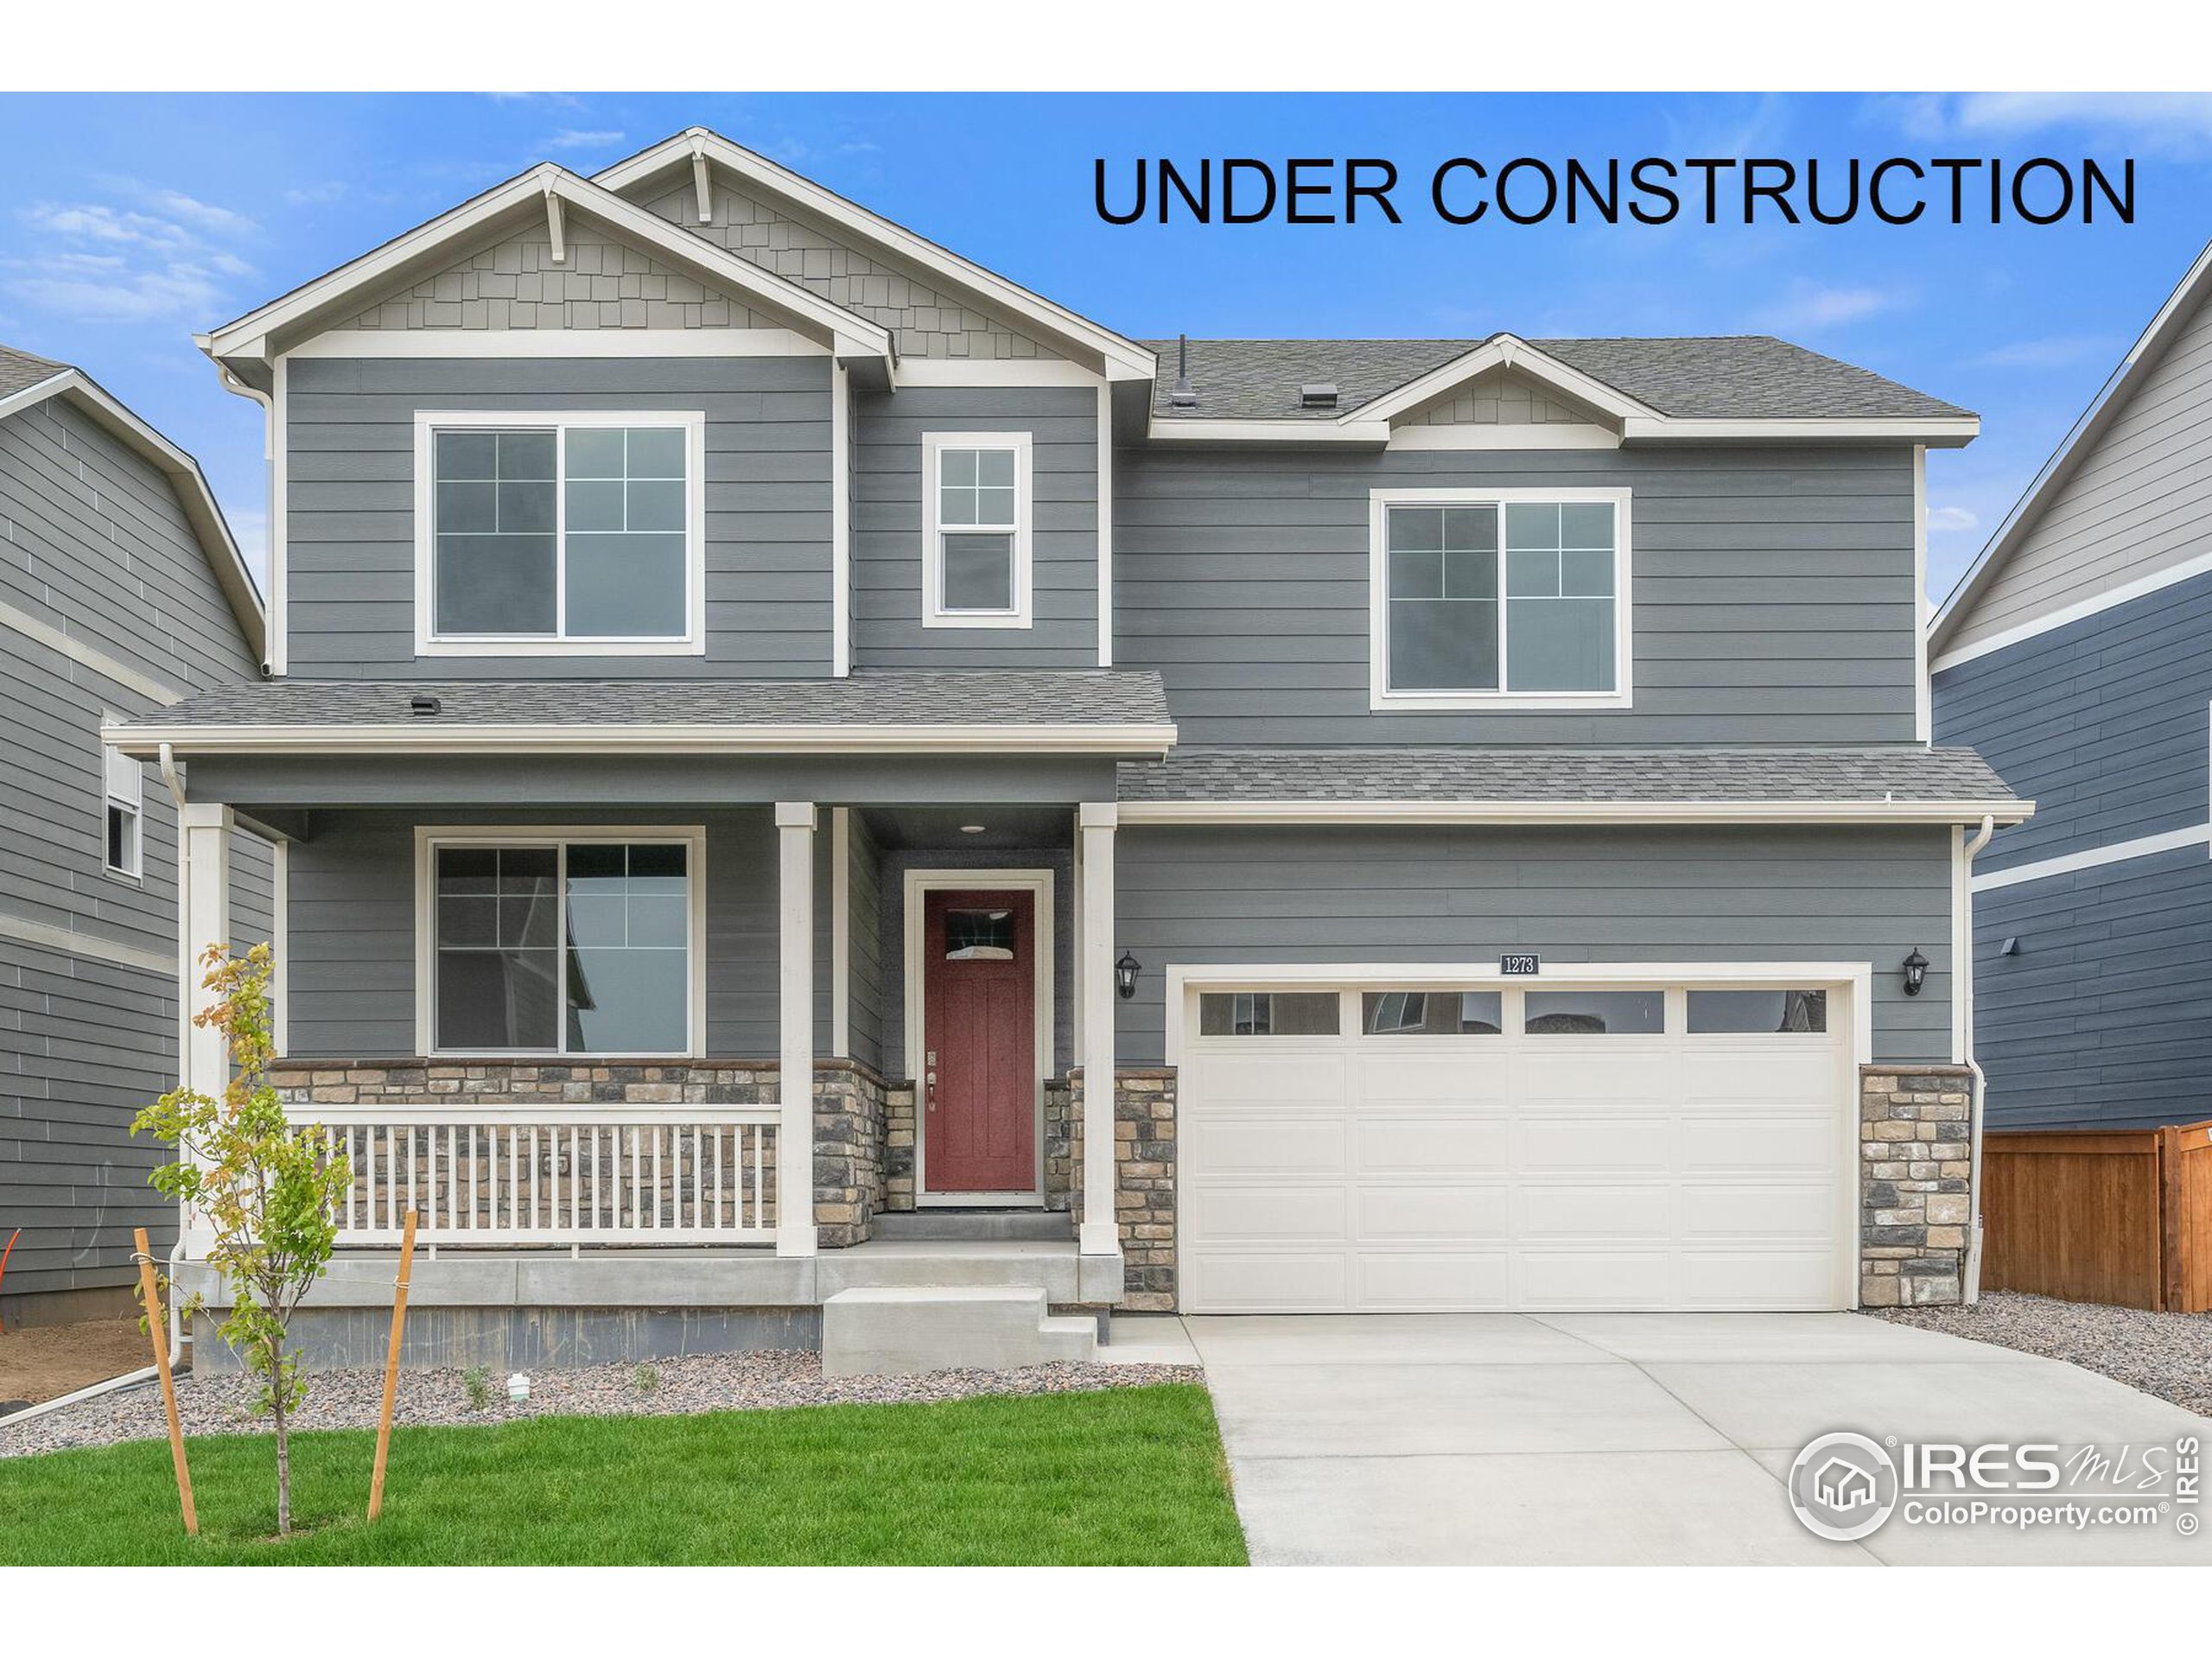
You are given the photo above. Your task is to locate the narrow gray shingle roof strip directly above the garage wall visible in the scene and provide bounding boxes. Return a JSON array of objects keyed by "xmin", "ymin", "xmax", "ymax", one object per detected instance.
[{"xmin": 1119, "ymin": 747, "xmax": 2018, "ymax": 803}]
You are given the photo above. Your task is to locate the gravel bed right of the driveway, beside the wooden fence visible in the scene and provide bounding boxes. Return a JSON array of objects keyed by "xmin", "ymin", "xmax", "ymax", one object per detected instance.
[{"xmin": 1867, "ymin": 1289, "xmax": 2212, "ymax": 1418}]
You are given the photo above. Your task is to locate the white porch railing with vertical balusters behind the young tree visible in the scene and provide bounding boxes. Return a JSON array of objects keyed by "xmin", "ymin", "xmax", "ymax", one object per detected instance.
[{"xmin": 292, "ymin": 1102, "xmax": 781, "ymax": 1248}]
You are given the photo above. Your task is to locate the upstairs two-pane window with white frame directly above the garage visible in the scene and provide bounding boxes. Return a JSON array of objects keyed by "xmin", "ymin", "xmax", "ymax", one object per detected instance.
[{"xmin": 1371, "ymin": 489, "xmax": 1630, "ymax": 708}]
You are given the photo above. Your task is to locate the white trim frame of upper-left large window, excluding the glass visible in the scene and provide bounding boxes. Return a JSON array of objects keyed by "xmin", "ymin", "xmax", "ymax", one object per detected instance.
[{"xmin": 414, "ymin": 410, "xmax": 706, "ymax": 657}]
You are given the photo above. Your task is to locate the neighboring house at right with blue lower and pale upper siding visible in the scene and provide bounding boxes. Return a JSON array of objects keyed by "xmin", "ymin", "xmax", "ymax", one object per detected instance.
[{"xmin": 1929, "ymin": 239, "xmax": 2212, "ymax": 1128}]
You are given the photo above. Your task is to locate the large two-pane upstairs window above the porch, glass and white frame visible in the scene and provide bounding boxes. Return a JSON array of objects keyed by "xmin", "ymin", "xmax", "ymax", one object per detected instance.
[{"xmin": 416, "ymin": 411, "xmax": 706, "ymax": 657}]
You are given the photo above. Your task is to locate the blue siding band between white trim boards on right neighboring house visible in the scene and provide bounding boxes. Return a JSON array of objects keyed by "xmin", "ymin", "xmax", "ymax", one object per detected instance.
[{"xmin": 1936, "ymin": 575, "xmax": 2212, "ymax": 874}]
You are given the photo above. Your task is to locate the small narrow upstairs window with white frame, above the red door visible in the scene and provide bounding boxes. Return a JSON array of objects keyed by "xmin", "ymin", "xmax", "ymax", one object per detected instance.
[{"xmin": 923, "ymin": 431, "xmax": 1028, "ymax": 628}]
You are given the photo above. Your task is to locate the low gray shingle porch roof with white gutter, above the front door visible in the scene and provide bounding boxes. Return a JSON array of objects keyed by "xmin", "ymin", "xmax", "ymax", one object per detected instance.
[{"xmin": 111, "ymin": 668, "xmax": 1174, "ymax": 754}]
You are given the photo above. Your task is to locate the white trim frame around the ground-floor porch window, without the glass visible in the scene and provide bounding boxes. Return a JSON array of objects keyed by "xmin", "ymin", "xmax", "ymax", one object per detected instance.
[{"xmin": 416, "ymin": 823, "xmax": 706, "ymax": 1062}]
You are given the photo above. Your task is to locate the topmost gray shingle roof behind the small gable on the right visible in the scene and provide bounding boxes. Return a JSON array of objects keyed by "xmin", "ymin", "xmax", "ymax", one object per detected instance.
[{"xmin": 1144, "ymin": 334, "xmax": 1967, "ymax": 420}]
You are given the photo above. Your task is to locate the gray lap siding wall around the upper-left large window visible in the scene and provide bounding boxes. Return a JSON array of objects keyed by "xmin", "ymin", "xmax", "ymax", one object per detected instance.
[{"xmin": 285, "ymin": 356, "xmax": 830, "ymax": 679}]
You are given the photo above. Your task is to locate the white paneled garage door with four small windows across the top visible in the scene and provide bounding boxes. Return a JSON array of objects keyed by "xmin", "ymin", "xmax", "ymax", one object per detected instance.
[{"xmin": 1179, "ymin": 982, "xmax": 1856, "ymax": 1312}]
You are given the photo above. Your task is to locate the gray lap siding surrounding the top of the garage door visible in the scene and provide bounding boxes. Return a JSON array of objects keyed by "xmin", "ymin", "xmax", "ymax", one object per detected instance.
[{"xmin": 1115, "ymin": 827, "xmax": 1951, "ymax": 1066}]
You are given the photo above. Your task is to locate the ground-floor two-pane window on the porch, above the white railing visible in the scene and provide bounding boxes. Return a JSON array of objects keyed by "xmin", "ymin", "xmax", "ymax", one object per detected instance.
[{"xmin": 418, "ymin": 830, "xmax": 706, "ymax": 1055}]
